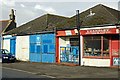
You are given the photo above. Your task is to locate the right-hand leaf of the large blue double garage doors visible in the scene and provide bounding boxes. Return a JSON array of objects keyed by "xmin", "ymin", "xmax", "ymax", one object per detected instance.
[{"xmin": 41, "ymin": 34, "xmax": 55, "ymax": 63}]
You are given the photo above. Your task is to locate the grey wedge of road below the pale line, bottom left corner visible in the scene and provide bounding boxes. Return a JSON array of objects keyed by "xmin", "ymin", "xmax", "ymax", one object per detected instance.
[{"xmin": 2, "ymin": 67, "xmax": 52, "ymax": 78}]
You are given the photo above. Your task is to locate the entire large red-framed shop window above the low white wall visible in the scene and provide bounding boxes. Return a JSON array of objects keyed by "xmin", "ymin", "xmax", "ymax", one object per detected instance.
[{"xmin": 84, "ymin": 36, "xmax": 109, "ymax": 57}]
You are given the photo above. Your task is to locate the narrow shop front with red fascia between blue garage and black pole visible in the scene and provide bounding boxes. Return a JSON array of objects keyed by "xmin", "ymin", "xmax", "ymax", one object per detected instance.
[{"xmin": 56, "ymin": 29, "xmax": 79, "ymax": 64}]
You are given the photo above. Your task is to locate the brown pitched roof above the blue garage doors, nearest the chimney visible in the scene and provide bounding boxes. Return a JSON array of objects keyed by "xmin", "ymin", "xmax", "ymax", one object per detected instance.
[{"xmin": 6, "ymin": 14, "xmax": 68, "ymax": 35}]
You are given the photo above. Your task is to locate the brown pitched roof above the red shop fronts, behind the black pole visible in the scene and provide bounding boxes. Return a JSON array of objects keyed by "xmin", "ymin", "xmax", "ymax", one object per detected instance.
[{"xmin": 56, "ymin": 4, "xmax": 120, "ymax": 27}]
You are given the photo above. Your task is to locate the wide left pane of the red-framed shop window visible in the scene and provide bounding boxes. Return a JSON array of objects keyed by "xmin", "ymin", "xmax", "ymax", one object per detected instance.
[{"xmin": 84, "ymin": 36, "xmax": 101, "ymax": 56}]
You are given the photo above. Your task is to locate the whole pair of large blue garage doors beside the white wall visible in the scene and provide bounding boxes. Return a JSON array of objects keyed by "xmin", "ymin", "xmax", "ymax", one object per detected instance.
[{"xmin": 30, "ymin": 34, "xmax": 55, "ymax": 63}]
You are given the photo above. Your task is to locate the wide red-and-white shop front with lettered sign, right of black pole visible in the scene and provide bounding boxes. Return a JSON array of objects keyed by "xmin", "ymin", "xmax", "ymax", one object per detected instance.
[{"xmin": 80, "ymin": 26, "xmax": 120, "ymax": 67}]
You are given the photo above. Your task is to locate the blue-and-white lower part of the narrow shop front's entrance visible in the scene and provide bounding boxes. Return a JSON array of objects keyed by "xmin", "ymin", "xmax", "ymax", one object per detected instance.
[{"xmin": 60, "ymin": 46, "xmax": 79, "ymax": 64}]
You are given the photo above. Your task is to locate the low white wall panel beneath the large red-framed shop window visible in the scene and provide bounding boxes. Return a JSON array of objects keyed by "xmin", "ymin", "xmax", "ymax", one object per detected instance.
[{"xmin": 82, "ymin": 58, "xmax": 110, "ymax": 67}]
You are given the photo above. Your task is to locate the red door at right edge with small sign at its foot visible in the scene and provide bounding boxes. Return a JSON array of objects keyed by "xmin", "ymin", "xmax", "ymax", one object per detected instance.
[{"xmin": 111, "ymin": 35, "xmax": 120, "ymax": 66}]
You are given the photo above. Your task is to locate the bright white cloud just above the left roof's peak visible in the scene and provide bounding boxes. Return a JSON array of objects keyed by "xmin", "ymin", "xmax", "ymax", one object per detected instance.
[{"xmin": 34, "ymin": 5, "xmax": 56, "ymax": 13}]
